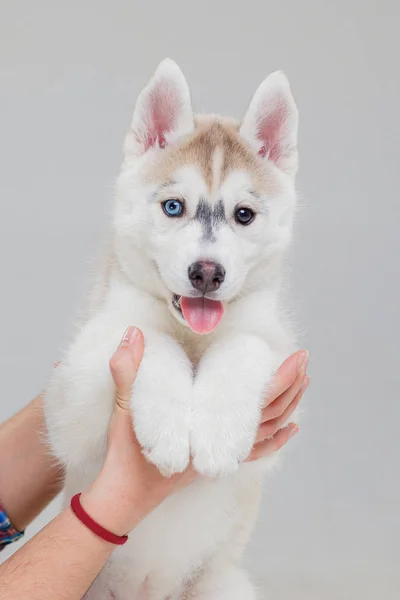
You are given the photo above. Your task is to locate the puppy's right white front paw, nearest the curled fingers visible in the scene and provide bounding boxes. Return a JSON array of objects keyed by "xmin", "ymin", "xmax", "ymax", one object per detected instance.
[{"xmin": 190, "ymin": 398, "xmax": 259, "ymax": 477}]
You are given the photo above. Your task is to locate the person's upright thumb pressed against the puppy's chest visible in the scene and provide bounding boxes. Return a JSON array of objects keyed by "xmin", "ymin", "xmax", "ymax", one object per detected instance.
[{"xmin": 110, "ymin": 326, "xmax": 144, "ymax": 414}]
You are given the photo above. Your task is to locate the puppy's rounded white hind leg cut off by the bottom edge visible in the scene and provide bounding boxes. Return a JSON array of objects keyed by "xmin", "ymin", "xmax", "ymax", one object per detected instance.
[{"xmin": 189, "ymin": 567, "xmax": 256, "ymax": 600}]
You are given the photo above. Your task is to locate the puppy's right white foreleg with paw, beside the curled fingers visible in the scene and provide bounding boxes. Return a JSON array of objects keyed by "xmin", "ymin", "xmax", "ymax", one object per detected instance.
[{"xmin": 190, "ymin": 333, "xmax": 273, "ymax": 476}]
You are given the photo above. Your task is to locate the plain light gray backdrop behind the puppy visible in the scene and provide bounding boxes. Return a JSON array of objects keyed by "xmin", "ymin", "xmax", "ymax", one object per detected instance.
[{"xmin": 0, "ymin": 0, "xmax": 400, "ymax": 600}]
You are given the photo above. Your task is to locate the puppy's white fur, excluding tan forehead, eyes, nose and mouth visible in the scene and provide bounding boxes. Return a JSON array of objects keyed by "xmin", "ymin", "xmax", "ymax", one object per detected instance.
[{"xmin": 45, "ymin": 61, "xmax": 297, "ymax": 600}]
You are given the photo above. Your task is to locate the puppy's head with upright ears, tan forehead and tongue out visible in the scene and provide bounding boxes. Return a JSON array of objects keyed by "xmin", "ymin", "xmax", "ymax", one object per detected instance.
[{"xmin": 114, "ymin": 60, "xmax": 298, "ymax": 333}]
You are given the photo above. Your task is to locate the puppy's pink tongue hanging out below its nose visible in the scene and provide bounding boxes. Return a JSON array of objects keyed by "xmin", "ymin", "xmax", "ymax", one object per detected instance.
[{"xmin": 181, "ymin": 297, "xmax": 224, "ymax": 334}]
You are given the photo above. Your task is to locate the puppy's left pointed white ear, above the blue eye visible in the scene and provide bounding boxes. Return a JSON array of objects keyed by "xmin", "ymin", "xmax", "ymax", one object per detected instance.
[{"xmin": 125, "ymin": 58, "xmax": 194, "ymax": 155}]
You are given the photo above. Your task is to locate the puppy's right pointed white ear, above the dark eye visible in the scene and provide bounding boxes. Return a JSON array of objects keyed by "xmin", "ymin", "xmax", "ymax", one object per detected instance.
[{"xmin": 240, "ymin": 71, "xmax": 298, "ymax": 176}]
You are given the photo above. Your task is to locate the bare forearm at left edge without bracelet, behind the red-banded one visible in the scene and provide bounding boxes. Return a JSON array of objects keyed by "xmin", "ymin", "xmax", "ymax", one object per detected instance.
[{"xmin": 0, "ymin": 396, "xmax": 63, "ymax": 530}]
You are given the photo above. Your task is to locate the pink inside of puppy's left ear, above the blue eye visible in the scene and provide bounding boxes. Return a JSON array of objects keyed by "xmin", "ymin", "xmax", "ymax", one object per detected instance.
[{"xmin": 144, "ymin": 80, "xmax": 181, "ymax": 151}]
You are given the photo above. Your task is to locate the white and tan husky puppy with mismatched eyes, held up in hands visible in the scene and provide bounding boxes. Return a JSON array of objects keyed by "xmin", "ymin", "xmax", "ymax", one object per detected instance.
[{"xmin": 45, "ymin": 59, "xmax": 298, "ymax": 600}]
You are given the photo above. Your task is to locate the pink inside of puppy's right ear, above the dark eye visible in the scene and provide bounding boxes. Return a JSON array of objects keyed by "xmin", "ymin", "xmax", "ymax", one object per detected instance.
[{"xmin": 257, "ymin": 104, "xmax": 288, "ymax": 163}]
